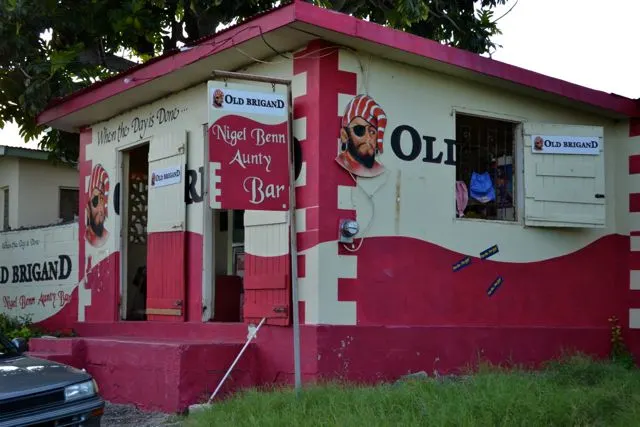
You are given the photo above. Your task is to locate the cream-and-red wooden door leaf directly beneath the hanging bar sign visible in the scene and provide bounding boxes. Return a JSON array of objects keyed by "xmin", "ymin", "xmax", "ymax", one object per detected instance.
[{"xmin": 244, "ymin": 211, "xmax": 291, "ymax": 326}]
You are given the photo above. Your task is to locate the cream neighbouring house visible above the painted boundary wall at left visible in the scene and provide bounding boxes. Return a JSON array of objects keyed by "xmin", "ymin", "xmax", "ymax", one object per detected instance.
[{"xmin": 0, "ymin": 146, "xmax": 79, "ymax": 231}]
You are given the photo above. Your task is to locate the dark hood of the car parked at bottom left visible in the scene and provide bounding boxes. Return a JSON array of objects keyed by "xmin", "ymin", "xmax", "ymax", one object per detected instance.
[{"xmin": 0, "ymin": 356, "xmax": 91, "ymax": 400}]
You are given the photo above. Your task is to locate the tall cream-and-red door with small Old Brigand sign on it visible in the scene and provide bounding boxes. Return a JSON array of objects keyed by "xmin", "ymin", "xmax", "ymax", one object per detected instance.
[{"xmin": 147, "ymin": 131, "xmax": 187, "ymax": 321}]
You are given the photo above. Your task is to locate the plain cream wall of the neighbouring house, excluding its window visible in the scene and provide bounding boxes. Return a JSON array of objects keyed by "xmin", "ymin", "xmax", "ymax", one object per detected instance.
[{"xmin": 0, "ymin": 157, "xmax": 78, "ymax": 229}]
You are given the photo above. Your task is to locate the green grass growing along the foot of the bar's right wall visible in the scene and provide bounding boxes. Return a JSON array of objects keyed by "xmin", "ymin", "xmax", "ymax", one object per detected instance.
[{"xmin": 184, "ymin": 355, "xmax": 640, "ymax": 427}]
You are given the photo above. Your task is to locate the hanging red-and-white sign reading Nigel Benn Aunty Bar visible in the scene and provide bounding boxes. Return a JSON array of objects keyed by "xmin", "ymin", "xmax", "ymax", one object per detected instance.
[{"xmin": 207, "ymin": 81, "xmax": 289, "ymax": 211}]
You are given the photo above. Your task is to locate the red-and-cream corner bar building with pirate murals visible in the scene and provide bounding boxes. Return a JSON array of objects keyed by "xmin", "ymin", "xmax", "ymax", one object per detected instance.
[{"xmin": 33, "ymin": 1, "xmax": 640, "ymax": 411}]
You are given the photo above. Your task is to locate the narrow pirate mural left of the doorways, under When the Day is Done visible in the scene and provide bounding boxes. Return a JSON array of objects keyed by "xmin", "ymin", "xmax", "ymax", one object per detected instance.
[{"xmin": 85, "ymin": 163, "xmax": 109, "ymax": 248}]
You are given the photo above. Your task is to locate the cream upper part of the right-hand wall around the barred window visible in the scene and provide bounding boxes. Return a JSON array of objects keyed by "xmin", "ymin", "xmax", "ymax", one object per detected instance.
[{"xmin": 338, "ymin": 51, "xmax": 628, "ymax": 262}]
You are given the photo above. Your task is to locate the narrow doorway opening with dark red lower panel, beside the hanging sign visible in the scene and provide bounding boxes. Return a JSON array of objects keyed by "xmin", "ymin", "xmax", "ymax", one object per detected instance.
[{"xmin": 212, "ymin": 209, "xmax": 244, "ymax": 322}]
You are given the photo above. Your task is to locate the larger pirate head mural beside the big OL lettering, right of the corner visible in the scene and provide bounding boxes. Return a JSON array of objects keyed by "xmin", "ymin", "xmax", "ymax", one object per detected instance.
[{"xmin": 336, "ymin": 95, "xmax": 387, "ymax": 178}]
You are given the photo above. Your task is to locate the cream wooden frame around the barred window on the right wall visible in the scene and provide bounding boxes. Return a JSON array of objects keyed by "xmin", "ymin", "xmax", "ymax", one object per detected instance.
[{"xmin": 450, "ymin": 106, "xmax": 529, "ymax": 227}]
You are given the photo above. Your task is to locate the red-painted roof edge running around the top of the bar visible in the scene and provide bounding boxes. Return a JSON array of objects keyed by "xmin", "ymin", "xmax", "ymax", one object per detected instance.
[{"xmin": 37, "ymin": 1, "xmax": 640, "ymax": 130}]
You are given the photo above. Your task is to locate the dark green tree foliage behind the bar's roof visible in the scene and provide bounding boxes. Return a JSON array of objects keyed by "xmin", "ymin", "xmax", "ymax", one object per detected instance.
[{"xmin": 0, "ymin": 0, "xmax": 507, "ymax": 161}]
